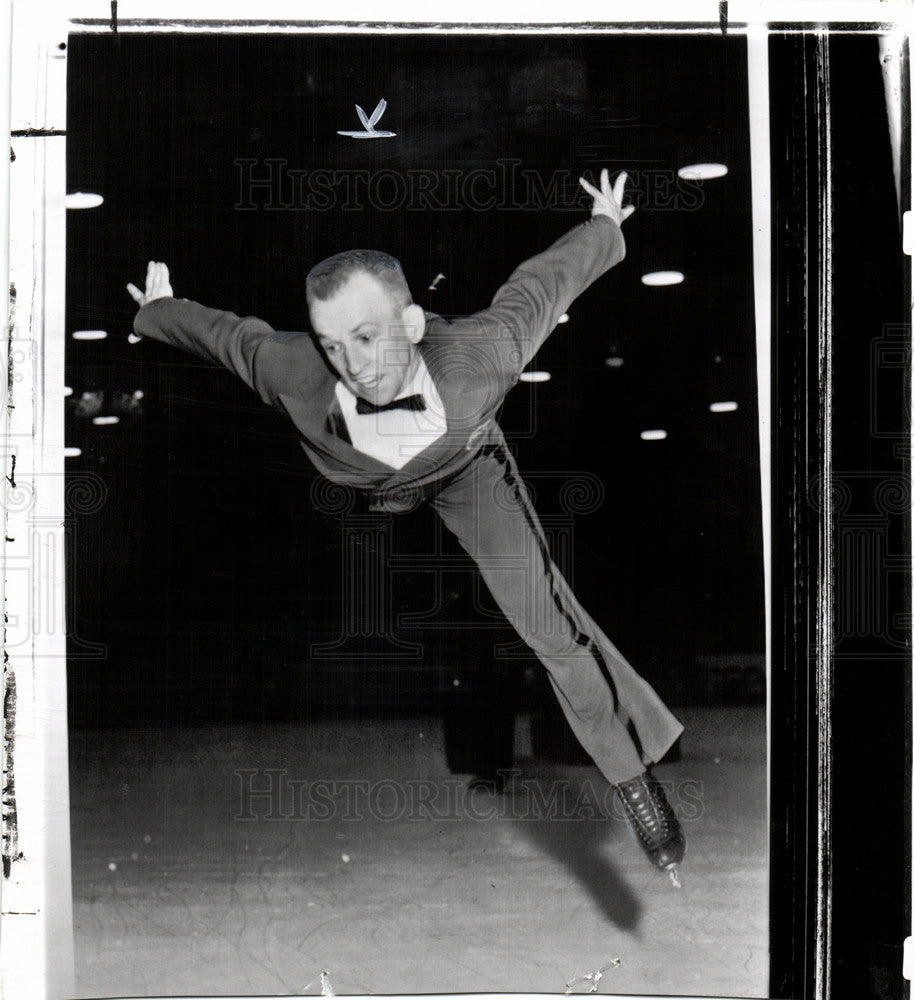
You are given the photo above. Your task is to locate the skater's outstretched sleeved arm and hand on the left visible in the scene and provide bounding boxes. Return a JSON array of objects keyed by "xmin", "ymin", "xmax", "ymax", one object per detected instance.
[{"xmin": 127, "ymin": 261, "xmax": 292, "ymax": 404}]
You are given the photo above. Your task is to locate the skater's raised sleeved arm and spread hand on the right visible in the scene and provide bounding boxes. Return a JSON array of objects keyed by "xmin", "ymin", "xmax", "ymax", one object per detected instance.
[{"xmin": 476, "ymin": 170, "xmax": 635, "ymax": 371}]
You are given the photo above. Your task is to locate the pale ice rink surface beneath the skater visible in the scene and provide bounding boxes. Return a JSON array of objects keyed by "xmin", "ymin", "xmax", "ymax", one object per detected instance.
[{"xmin": 71, "ymin": 707, "xmax": 768, "ymax": 997}]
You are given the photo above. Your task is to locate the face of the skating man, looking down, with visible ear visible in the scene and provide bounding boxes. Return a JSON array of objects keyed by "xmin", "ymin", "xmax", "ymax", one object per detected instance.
[{"xmin": 311, "ymin": 271, "xmax": 424, "ymax": 406}]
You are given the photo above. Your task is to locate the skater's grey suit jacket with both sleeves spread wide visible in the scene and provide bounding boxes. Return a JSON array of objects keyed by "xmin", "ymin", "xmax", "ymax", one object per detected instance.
[{"xmin": 133, "ymin": 216, "xmax": 625, "ymax": 509}]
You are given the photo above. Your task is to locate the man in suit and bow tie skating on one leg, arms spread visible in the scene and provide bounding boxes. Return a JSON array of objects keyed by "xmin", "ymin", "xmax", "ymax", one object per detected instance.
[{"xmin": 127, "ymin": 170, "xmax": 685, "ymax": 873}]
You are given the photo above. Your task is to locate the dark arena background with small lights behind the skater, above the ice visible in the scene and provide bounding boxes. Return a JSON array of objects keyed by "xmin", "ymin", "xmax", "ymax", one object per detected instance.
[{"xmin": 66, "ymin": 35, "xmax": 764, "ymax": 726}]
